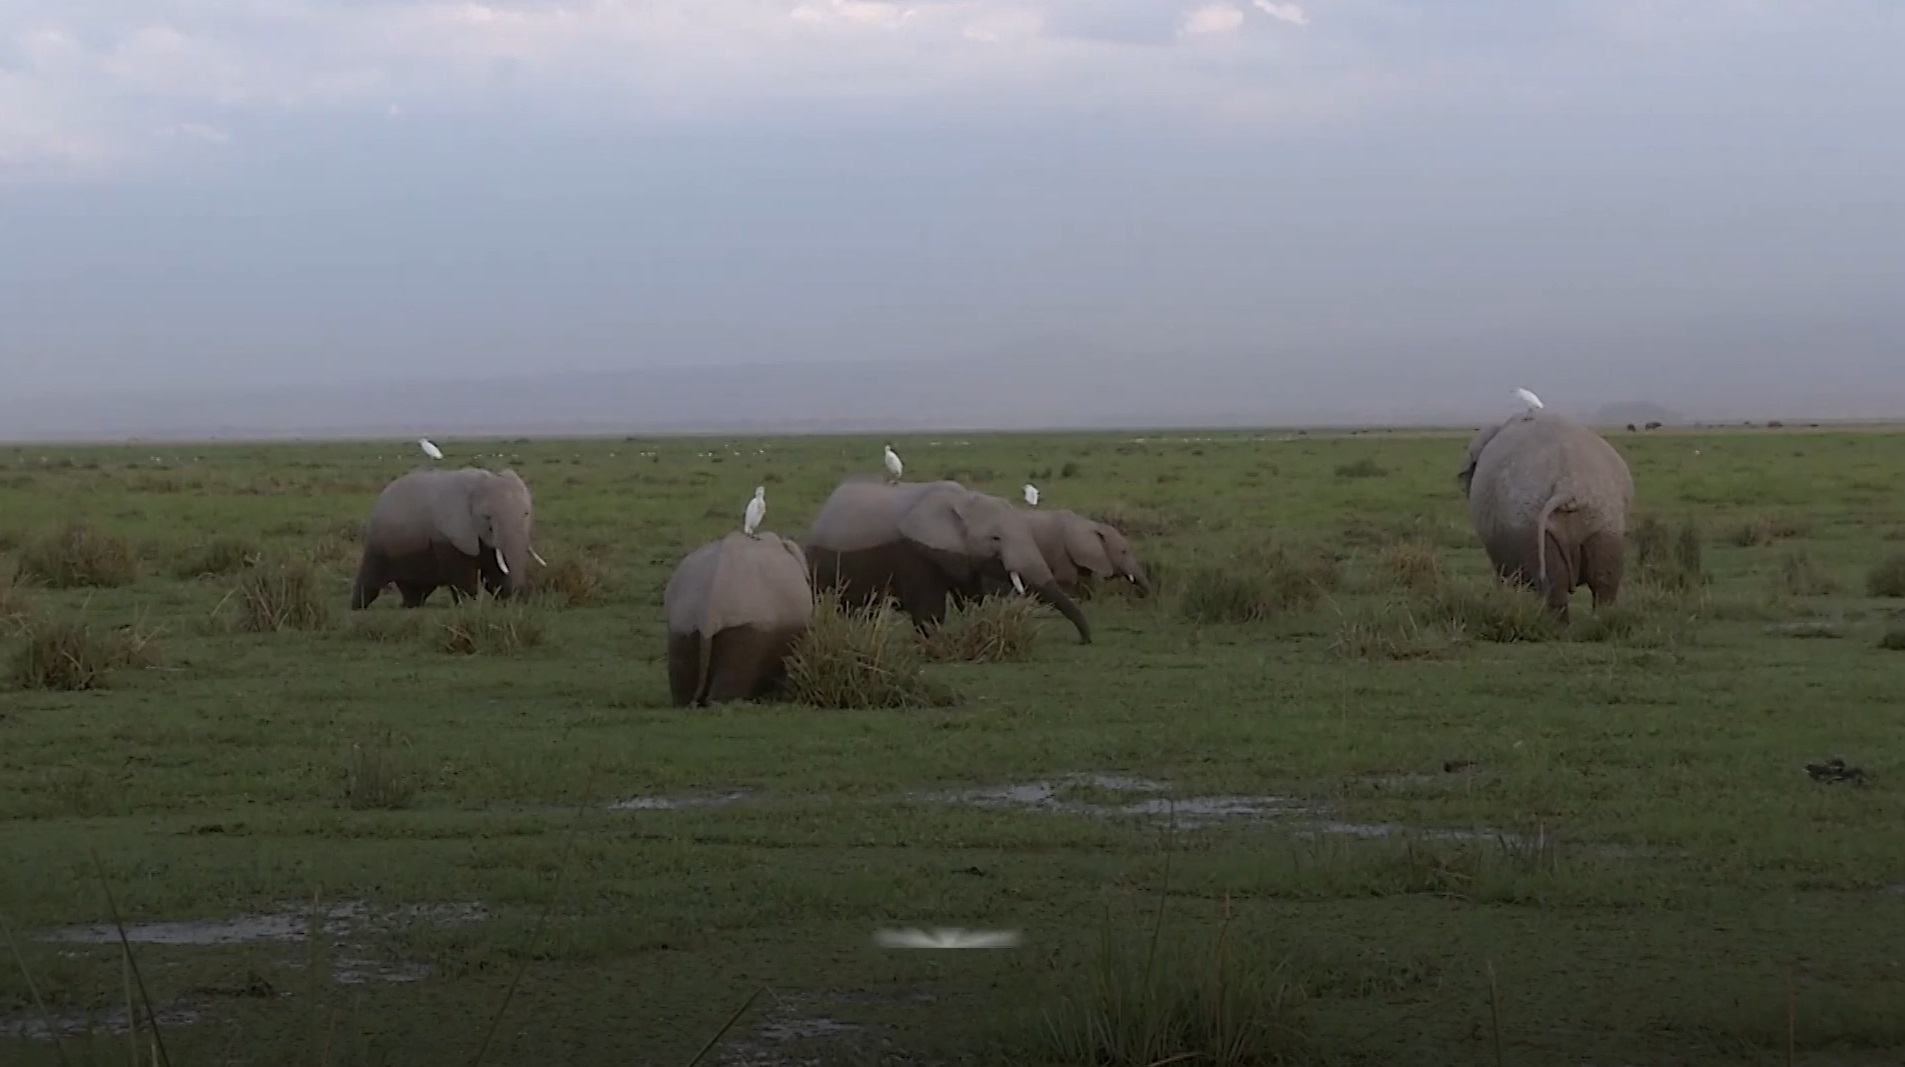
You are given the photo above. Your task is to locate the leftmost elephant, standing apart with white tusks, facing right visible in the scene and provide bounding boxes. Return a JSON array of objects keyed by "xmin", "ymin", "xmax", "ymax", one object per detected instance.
[{"xmin": 351, "ymin": 467, "xmax": 543, "ymax": 610}]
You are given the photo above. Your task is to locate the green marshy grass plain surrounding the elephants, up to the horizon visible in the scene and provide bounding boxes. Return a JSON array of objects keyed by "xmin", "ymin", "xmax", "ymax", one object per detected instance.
[{"xmin": 0, "ymin": 431, "xmax": 1905, "ymax": 1065}]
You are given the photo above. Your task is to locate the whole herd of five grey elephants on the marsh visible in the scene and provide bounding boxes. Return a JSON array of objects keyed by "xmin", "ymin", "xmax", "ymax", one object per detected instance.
[{"xmin": 351, "ymin": 408, "xmax": 1634, "ymax": 705}]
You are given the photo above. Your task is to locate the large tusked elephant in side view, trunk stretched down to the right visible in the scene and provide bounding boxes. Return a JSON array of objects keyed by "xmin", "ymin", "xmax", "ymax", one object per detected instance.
[{"xmin": 806, "ymin": 478, "xmax": 1092, "ymax": 644}]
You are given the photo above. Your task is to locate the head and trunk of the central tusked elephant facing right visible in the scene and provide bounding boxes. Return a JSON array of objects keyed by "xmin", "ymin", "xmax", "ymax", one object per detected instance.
[{"xmin": 899, "ymin": 486, "xmax": 1092, "ymax": 644}]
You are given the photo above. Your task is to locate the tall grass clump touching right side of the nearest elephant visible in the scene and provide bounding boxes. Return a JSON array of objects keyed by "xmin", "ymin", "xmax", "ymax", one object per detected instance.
[{"xmin": 787, "ymin": 589, "xmax": 956, "ymax": 711}]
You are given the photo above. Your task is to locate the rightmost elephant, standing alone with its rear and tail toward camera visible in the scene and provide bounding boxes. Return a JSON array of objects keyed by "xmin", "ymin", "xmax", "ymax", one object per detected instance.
[{"xmin": 1457, "ymin": 410, "xmax": 1634, "ymax": 621}]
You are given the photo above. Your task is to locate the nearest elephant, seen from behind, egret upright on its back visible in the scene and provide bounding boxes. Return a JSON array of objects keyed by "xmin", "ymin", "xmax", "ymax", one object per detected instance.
[{"xmin": 661, "ymin": 534, "xmax": 813, "ymax": 707}]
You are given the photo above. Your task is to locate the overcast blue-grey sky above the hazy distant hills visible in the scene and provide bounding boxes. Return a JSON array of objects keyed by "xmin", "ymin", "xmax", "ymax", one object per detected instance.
[{"xmin": 0, "ymin": 0, "xmax": 1905, "ymax": 424}]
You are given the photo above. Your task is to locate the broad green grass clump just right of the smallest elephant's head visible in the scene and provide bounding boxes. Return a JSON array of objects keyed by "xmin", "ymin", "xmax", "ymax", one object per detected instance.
[{"xmin": 1177, "ymin": 539, "xmax": 1343, "ymax": 623}]
